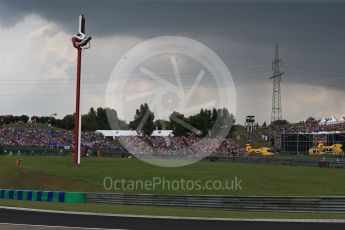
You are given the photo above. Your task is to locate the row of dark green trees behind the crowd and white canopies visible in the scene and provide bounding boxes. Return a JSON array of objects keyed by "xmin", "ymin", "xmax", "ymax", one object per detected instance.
[{"xmin": 0, "ymin": 103, "xmax": 235, "ymax": 136}]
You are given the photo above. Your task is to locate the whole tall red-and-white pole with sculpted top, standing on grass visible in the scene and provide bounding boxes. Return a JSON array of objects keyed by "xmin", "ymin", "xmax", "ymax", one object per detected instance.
[{"xmin": 72, "ymin": 15, "xmax": 91, "ymax": 165}]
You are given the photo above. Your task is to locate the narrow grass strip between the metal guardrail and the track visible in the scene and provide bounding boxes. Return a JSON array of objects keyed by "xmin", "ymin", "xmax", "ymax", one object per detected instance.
[{"xmin": 0, "ymin": 200, "xmax": 345, "ymax": 219}]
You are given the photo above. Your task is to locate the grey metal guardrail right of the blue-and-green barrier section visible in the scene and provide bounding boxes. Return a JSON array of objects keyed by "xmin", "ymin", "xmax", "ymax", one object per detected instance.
[{"xmin": 85, "ymin": 193, "xmax": 345, "ymax": 213}]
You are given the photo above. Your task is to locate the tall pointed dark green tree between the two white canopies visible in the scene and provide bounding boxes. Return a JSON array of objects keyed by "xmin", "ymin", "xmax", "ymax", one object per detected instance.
[{"xmin": 129, "ymin": 103, "xmax": 155, "ymax": 135}]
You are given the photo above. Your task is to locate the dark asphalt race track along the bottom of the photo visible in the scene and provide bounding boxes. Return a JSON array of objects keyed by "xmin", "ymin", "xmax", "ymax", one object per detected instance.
[{"xmin": 0, "ymin": 208, "xmax": 345, "ymax": 230}]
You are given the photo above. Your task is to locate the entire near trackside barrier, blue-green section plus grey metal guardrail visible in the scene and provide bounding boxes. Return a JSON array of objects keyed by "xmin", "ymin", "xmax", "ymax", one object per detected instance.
[{"xmin": 0, "ymin": 189, "xmax": 345, "ymax": 213}]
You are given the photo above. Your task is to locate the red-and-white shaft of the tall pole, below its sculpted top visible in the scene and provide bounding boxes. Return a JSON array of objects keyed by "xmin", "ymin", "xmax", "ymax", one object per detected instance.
[{"xmin": 73, "ymin": 47, "xmax": 81, "ymax": 165}]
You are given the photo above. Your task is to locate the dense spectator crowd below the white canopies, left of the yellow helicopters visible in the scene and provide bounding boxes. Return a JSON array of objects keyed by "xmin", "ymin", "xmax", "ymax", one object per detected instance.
[{"xmin": 0, "ymin": 128, "xmax": 243, "ymax": 156}]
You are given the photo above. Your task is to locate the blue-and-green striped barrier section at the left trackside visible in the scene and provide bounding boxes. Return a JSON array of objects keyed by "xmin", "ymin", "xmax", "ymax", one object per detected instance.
[{"xmin": 0, "ymin": 189, "xmax": 85, "ymax": 203}]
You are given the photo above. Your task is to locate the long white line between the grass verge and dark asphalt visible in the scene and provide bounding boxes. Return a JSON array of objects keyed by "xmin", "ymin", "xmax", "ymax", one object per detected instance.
[{"xmin": 0, "ymin": 206, "xmax": 345, "ymax": 224}]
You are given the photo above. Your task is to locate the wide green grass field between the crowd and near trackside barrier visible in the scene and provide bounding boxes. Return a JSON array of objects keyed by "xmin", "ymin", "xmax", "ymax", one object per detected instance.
[{"xmin": 0, "ymin": 156, "xmax": 345, "ymax": 195}]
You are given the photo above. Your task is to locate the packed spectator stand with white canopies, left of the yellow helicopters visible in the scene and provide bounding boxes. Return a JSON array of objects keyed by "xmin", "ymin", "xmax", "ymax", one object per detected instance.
[{"xmin": 0, "ymin": 126, "xmax": 243, "ymax": 155}]
